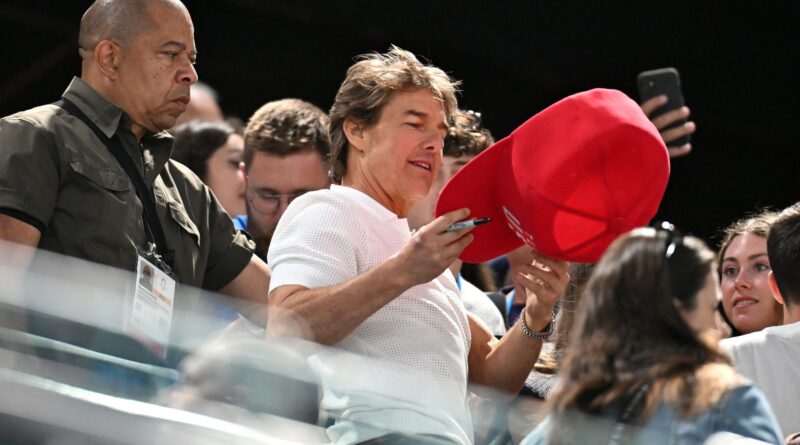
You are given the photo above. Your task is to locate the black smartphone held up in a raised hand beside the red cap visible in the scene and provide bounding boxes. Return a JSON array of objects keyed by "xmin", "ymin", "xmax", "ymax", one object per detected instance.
[{"xmin": 636, "ymin": 68, "xmax": 690, "ymax": 147}]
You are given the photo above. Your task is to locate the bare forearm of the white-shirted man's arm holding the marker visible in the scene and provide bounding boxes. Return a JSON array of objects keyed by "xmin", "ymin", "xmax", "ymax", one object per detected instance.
[{"xmin": 267, "ymin": 253, "xmax": 412, "ymax": 345}]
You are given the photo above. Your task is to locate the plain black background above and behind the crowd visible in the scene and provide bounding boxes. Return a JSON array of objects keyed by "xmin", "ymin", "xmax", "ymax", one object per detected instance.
[{"xmin": 0, "ymin": 0, "xmax": 800, "ymax": 243}]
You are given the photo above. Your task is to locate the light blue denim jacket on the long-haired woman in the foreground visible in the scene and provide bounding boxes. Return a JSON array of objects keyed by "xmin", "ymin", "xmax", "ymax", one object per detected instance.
[{"xmin": 522, "ymin": 384, "xmax": 783, "ymax": 445}]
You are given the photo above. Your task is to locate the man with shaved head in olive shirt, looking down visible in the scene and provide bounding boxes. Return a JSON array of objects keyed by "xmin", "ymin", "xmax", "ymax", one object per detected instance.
[{"xmin": 0, "ymin": 0, "xmax": 269, "ymax": 302}]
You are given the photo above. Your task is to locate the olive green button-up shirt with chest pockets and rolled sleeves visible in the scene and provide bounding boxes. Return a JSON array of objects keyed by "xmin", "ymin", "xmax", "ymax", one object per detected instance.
[{"xmin": 0, "ymin": 78, "xmax": 253, "ymax": 290}]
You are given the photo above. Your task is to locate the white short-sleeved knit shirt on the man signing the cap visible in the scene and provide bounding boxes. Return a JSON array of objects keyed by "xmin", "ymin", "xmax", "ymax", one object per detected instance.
[{"xmin": 268, "ymin": 185, "xmax": 473, "ymax": 444}]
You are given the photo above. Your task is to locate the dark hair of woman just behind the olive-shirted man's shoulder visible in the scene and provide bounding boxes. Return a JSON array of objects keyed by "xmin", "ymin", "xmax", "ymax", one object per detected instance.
[{"xmin": 172, "ymin": 121, "xmax": 236, "ymax": 181}]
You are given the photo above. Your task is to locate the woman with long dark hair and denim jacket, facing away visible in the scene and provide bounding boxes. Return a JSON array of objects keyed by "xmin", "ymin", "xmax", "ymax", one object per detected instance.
[{"xmin": 524, "ymin": 223, "xmax": 781, "ymax": 445}]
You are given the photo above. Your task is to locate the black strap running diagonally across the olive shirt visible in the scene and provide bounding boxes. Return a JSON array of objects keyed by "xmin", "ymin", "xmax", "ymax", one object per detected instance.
[{"xmin": 55, "ymin": 99, "xmax": 173, "ymax": 266}]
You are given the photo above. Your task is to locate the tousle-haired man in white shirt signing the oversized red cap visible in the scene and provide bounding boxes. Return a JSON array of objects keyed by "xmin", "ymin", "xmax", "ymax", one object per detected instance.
[{"xmin": 268, "ymin": 47, "xmax": 569, "ymax": 444}]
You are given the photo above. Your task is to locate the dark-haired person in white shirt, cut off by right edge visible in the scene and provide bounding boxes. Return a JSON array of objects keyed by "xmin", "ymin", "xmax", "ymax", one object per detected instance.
[{"xmin": 722, "ymin": 202, "xmax": 800, "ymax": 434}]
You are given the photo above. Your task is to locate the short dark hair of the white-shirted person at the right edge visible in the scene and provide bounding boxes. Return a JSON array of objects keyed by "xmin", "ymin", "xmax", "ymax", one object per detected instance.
[{"xmin": 767, "ymin": 202, "xmax": 800, "ymax": 306}]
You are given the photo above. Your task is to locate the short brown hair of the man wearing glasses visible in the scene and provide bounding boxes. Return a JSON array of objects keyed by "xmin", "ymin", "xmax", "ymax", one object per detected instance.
[{"xmin": 244, "ymin": 99, "xmax": 331, "ymax": 168}]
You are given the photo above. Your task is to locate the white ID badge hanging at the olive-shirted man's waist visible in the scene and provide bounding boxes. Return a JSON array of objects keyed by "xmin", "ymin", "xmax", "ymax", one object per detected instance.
[{"xmin": 125, "ymin": 245, "xmax": 176, "ymax": 360}]
